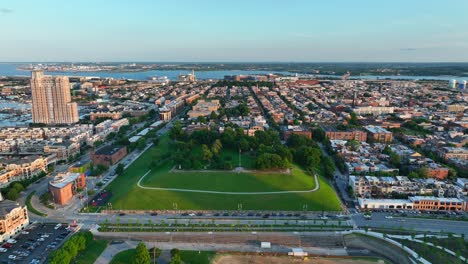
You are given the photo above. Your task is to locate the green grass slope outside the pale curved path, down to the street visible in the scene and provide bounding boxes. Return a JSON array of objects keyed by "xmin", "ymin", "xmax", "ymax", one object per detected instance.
[{"xmin": 107, "ymin": 137, "xmax": 340, "ymax": 211}]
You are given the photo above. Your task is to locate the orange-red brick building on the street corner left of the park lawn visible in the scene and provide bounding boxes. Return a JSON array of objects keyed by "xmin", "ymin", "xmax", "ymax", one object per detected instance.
[{"xmin": 49, "ymin": 173, "xmax": 86, "ymax": 205}]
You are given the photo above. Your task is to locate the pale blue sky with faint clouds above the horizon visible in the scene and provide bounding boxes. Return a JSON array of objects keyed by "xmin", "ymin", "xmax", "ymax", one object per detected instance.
[{"xmin": 0, "ymin": 0, "xmax": 468, "ymax": 62}]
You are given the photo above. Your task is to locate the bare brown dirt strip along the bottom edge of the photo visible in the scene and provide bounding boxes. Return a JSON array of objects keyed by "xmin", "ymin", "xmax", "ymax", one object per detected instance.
[{"xmin": 212, "ymin": 255, "xmax": 385, "ymax": 264}]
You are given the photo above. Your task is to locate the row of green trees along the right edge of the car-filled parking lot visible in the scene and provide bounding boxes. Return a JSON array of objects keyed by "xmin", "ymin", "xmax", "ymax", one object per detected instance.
[{"xmin": 48, "ymin": 231, "xmax": 93, "ymax": 264}]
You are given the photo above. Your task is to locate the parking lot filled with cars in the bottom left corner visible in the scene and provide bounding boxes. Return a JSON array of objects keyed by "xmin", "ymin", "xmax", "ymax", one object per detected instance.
[{"xmin": 0, "ymin": 224, "xmax": 71, "ymax": 263}]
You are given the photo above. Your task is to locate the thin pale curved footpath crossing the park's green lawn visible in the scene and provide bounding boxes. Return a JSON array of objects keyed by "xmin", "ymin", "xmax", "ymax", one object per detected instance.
[{"xmin": 137, "ymin": 170, "xmax": 320, "ymax": 195}]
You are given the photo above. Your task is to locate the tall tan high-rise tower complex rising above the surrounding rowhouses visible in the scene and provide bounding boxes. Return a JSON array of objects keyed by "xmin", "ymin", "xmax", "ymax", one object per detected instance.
[{"xmin": 31, "ymin": 70, "xmax": 79, "ymax": 124}]
